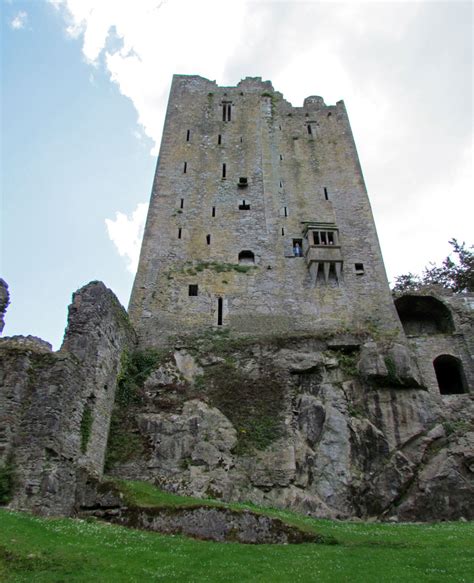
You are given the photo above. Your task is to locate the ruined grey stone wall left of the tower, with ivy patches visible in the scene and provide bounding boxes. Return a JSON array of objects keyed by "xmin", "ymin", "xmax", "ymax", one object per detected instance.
[{"xmin": 0, "ymin": 282, "xmax": 135, "ymax": 514}]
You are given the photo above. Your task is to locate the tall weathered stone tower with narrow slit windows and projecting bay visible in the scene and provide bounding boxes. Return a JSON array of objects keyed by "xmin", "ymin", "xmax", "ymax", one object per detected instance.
[{"xmin": 129, "ymin": 75, "xmax": 401, "ymax": 345}]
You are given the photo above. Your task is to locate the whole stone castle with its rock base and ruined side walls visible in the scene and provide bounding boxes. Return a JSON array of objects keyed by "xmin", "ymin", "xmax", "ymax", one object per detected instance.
[{"xmin": 0, "ymin": 75, "xmax": 474, "ymax": 521}]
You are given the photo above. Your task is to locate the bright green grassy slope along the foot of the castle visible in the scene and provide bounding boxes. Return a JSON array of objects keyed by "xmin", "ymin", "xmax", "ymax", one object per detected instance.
[{"xmin": 0, "ymin": 482, "xmax": 474, "ymax": 583}]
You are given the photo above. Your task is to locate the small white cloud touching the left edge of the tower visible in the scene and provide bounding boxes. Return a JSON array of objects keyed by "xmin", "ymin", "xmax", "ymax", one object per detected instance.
[{"xmin": 105, "ymin": 202, "xmax": 148, "ymax": 273}]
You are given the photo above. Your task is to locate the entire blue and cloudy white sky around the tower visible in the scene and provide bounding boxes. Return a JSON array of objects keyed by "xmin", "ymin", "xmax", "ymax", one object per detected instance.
[{"xmin": 0, "ymin": 0, "xmax": 474, "ymax": 347}]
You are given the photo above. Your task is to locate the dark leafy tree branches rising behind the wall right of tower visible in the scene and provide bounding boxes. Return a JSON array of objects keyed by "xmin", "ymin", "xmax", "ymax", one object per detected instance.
[{"xmin": 393, "ymin": 239, "xmax": 474, "ymax": 293}]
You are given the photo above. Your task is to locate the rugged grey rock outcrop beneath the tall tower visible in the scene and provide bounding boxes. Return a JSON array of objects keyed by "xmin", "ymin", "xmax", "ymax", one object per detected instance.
[{"xmin": 108, "ymin": 338, "xmax": 474, "ymax": 520}]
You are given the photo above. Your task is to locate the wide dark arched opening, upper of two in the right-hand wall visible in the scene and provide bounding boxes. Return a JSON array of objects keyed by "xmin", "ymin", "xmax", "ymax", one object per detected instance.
[{"xmin": 395, "ymin": 295, "xmax": 454, "ymax": 336}]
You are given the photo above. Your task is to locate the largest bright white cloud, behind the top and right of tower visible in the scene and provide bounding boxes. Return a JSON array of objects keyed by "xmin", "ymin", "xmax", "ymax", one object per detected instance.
[{"xmin": 49, "ymin": 0, "xmax": 472, "ymax": 275}]
